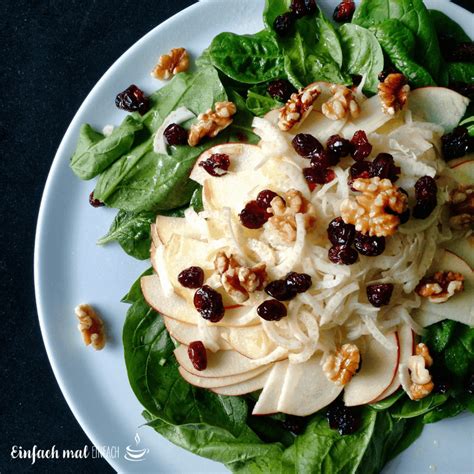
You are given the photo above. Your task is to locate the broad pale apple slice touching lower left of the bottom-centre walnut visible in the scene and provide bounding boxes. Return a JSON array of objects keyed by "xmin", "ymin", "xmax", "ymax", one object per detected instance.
[{"xmin": 278, "ymin": 355, "xmax": 343, "ymax": 416}]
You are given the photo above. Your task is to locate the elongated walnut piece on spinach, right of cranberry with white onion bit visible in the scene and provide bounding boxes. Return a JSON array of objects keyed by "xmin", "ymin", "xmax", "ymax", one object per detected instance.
[{"xmin": 188, "ymin": 101, "xmax": 237, "ymax": 146}]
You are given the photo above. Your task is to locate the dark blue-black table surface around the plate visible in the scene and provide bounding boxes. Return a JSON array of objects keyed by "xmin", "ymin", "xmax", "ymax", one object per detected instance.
[{"xmin": 0, "ymin": 0, "xmax": 472, "ymax": 473}]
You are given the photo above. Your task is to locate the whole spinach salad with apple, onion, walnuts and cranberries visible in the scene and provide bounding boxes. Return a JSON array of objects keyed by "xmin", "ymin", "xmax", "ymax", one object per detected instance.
[{"xmin": 70, "ymin": 0, "xmax": 474, "ymax": 473}]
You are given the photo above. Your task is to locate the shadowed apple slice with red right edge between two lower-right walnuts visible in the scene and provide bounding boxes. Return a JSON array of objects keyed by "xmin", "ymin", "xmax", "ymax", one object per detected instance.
[{"xmin": 344, "ymin": 332, "xmax": 399, "ymax": 407}]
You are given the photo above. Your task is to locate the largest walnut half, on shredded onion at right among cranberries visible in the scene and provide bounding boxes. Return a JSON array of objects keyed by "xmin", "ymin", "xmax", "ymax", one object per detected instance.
[{"xmin": 341, "ymin": 177, "xmax": 408, "ymax": 237}]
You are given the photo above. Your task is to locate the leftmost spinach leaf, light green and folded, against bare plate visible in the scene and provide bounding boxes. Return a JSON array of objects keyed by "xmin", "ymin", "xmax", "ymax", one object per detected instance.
[{"xmin": 70, "ymin": 115, "xmax": 143, "ymax": 179}]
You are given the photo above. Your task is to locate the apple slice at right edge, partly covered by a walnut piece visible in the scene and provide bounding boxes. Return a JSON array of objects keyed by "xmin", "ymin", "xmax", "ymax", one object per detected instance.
[{"xmin": 415, "ymin": 250, "xmax": 474, "ymax": 327}]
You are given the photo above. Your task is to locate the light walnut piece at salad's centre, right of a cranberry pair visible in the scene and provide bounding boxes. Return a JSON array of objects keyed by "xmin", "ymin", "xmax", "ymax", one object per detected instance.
[{"xmin": 266, "ymin": 189, "xmax": 316, "ymax": 243}]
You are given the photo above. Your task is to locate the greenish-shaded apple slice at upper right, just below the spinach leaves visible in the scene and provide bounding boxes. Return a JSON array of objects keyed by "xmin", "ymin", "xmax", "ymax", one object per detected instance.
[{"xmin": 408, "ymin": 87, "xmax": 469, "ymax": 133}]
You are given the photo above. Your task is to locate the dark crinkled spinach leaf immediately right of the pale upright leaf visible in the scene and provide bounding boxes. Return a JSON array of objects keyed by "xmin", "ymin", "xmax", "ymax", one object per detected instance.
[{"xmin": 370, "ymin": 20, "xmax": 435, "ymax": 87}]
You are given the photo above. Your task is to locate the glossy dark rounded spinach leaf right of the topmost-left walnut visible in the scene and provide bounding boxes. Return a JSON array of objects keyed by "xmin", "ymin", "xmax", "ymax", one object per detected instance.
[{"xmin": 209, "ymin": 30, "xmax": 284, "ymax": 84}]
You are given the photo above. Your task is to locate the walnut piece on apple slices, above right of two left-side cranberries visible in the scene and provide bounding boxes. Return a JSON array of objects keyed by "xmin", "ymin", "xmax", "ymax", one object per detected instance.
[{"xmin": 214, "ymin": 252, "xmax": 267, "ymax": 303}]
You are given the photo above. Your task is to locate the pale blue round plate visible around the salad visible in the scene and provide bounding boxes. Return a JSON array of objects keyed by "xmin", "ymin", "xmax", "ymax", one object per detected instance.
[{"xmin": 35, "ymin": 0, "xmax": 474, "ymax": 473}]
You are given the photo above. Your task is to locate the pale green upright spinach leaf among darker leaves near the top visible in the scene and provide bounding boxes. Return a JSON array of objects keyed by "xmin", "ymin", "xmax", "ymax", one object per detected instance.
[{"xmin": 339, "ymin": 23, "xmax": 384, "ymax": 94}]
